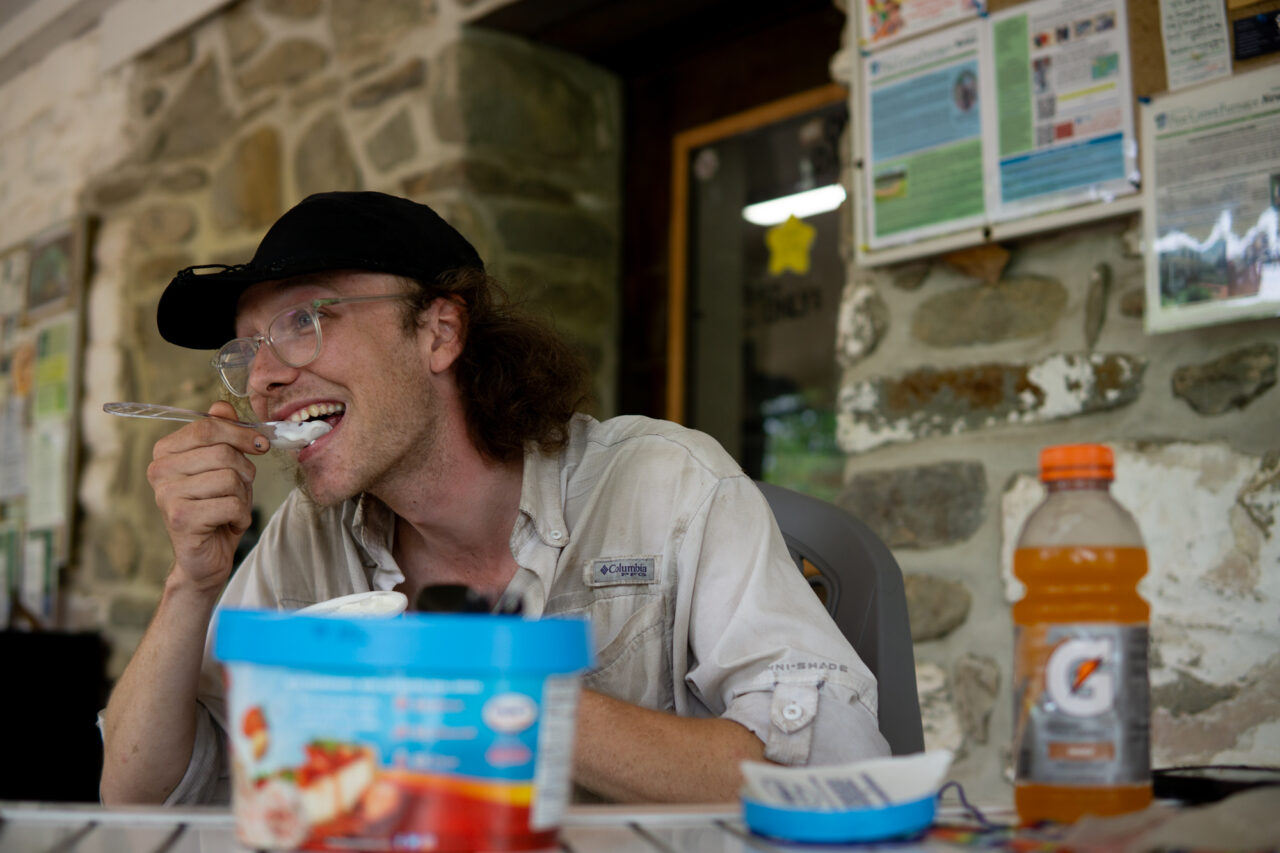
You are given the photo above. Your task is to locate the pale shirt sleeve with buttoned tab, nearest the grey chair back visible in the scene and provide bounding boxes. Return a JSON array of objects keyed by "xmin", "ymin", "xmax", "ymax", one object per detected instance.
[{"xmin": 680, "ymin": 476, "xmax": 890, "ymax": 765}]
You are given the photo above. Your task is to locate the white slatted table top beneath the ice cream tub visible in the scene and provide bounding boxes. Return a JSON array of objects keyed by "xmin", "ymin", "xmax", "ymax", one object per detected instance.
[{"xmin": 0, "ymin": 802, "xmax": 998, "ymax": 853}]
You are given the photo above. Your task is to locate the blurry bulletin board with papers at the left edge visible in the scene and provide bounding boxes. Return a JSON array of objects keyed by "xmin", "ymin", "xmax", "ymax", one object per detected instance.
[{"xmin": 0, "ymin": 218, "xmax": 90, "ymax": 629}]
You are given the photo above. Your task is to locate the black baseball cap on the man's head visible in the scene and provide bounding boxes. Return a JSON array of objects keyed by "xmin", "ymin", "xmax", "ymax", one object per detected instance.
[{"xmin": 156, "ymin": 192, "xmax": 484, "ymax": 350}]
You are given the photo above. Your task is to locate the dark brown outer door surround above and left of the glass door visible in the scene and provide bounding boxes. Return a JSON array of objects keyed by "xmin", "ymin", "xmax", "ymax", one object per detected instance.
[{"xmin": 472, "ymin": 0, "xmax": 845, "ymax": 418}]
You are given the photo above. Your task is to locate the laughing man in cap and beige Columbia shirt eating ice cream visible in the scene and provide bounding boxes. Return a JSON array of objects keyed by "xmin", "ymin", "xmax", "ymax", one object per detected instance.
[{"xmin": 101, "ymin": 192, "xmax": 888, "ymax": 803}]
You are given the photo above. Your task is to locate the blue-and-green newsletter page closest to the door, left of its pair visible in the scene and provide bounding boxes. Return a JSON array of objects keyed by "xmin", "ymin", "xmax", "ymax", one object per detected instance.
[{"xmin": 861, "ymin": 22, "xmax": 989, "ymax": 248}]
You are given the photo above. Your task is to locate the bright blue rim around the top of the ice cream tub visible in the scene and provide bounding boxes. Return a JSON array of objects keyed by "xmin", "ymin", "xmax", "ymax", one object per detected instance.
[{"xmin": 214, "ymin": 610, "xmax": 594, "ymax": 674}]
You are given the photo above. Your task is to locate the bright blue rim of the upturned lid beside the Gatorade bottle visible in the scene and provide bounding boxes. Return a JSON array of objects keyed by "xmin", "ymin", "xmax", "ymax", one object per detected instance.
[{"xmin": 742, "ymin": 794, "xmax": 938, "ymax": 843}]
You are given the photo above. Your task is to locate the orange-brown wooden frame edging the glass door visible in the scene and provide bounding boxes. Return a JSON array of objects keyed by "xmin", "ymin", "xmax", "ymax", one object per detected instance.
[{"xmin": 666, "ymin": 83, "xmax": 849, "ymax": 423}]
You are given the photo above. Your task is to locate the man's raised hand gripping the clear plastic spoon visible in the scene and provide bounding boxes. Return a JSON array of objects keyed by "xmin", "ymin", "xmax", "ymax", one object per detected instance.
[{"xmin": 147, "ymin": 402, "xmax": 270, "ymax": 590}]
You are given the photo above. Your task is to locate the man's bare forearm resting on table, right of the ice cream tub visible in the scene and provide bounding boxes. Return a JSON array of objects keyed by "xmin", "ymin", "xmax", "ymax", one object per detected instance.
[{"xmin": 573, "ymin": 690, "xmax": 764, "ymax": 803}]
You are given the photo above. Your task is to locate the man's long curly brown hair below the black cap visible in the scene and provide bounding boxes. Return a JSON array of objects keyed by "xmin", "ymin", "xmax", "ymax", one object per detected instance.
[{"xmin": 404, "ymin": 268, "xmax": 590, "ymax": 462}]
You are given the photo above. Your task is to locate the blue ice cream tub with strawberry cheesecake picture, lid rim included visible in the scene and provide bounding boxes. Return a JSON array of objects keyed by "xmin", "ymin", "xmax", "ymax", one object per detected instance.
[{"xmin": 214, "ymin": 610, "xmax": 593, "ymax": 850}]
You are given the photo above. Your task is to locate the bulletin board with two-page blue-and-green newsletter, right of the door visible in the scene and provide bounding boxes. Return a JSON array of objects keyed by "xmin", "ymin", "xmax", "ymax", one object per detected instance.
[{"xmin": 850, "ymin": 0, "xmax": 1280, "ymax": 266}]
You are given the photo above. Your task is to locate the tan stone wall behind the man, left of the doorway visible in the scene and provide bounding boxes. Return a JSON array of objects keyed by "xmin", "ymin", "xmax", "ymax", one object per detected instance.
[{"xmin": 70, "ymin": 0, "xmax": 621, "ymax": 674}]
